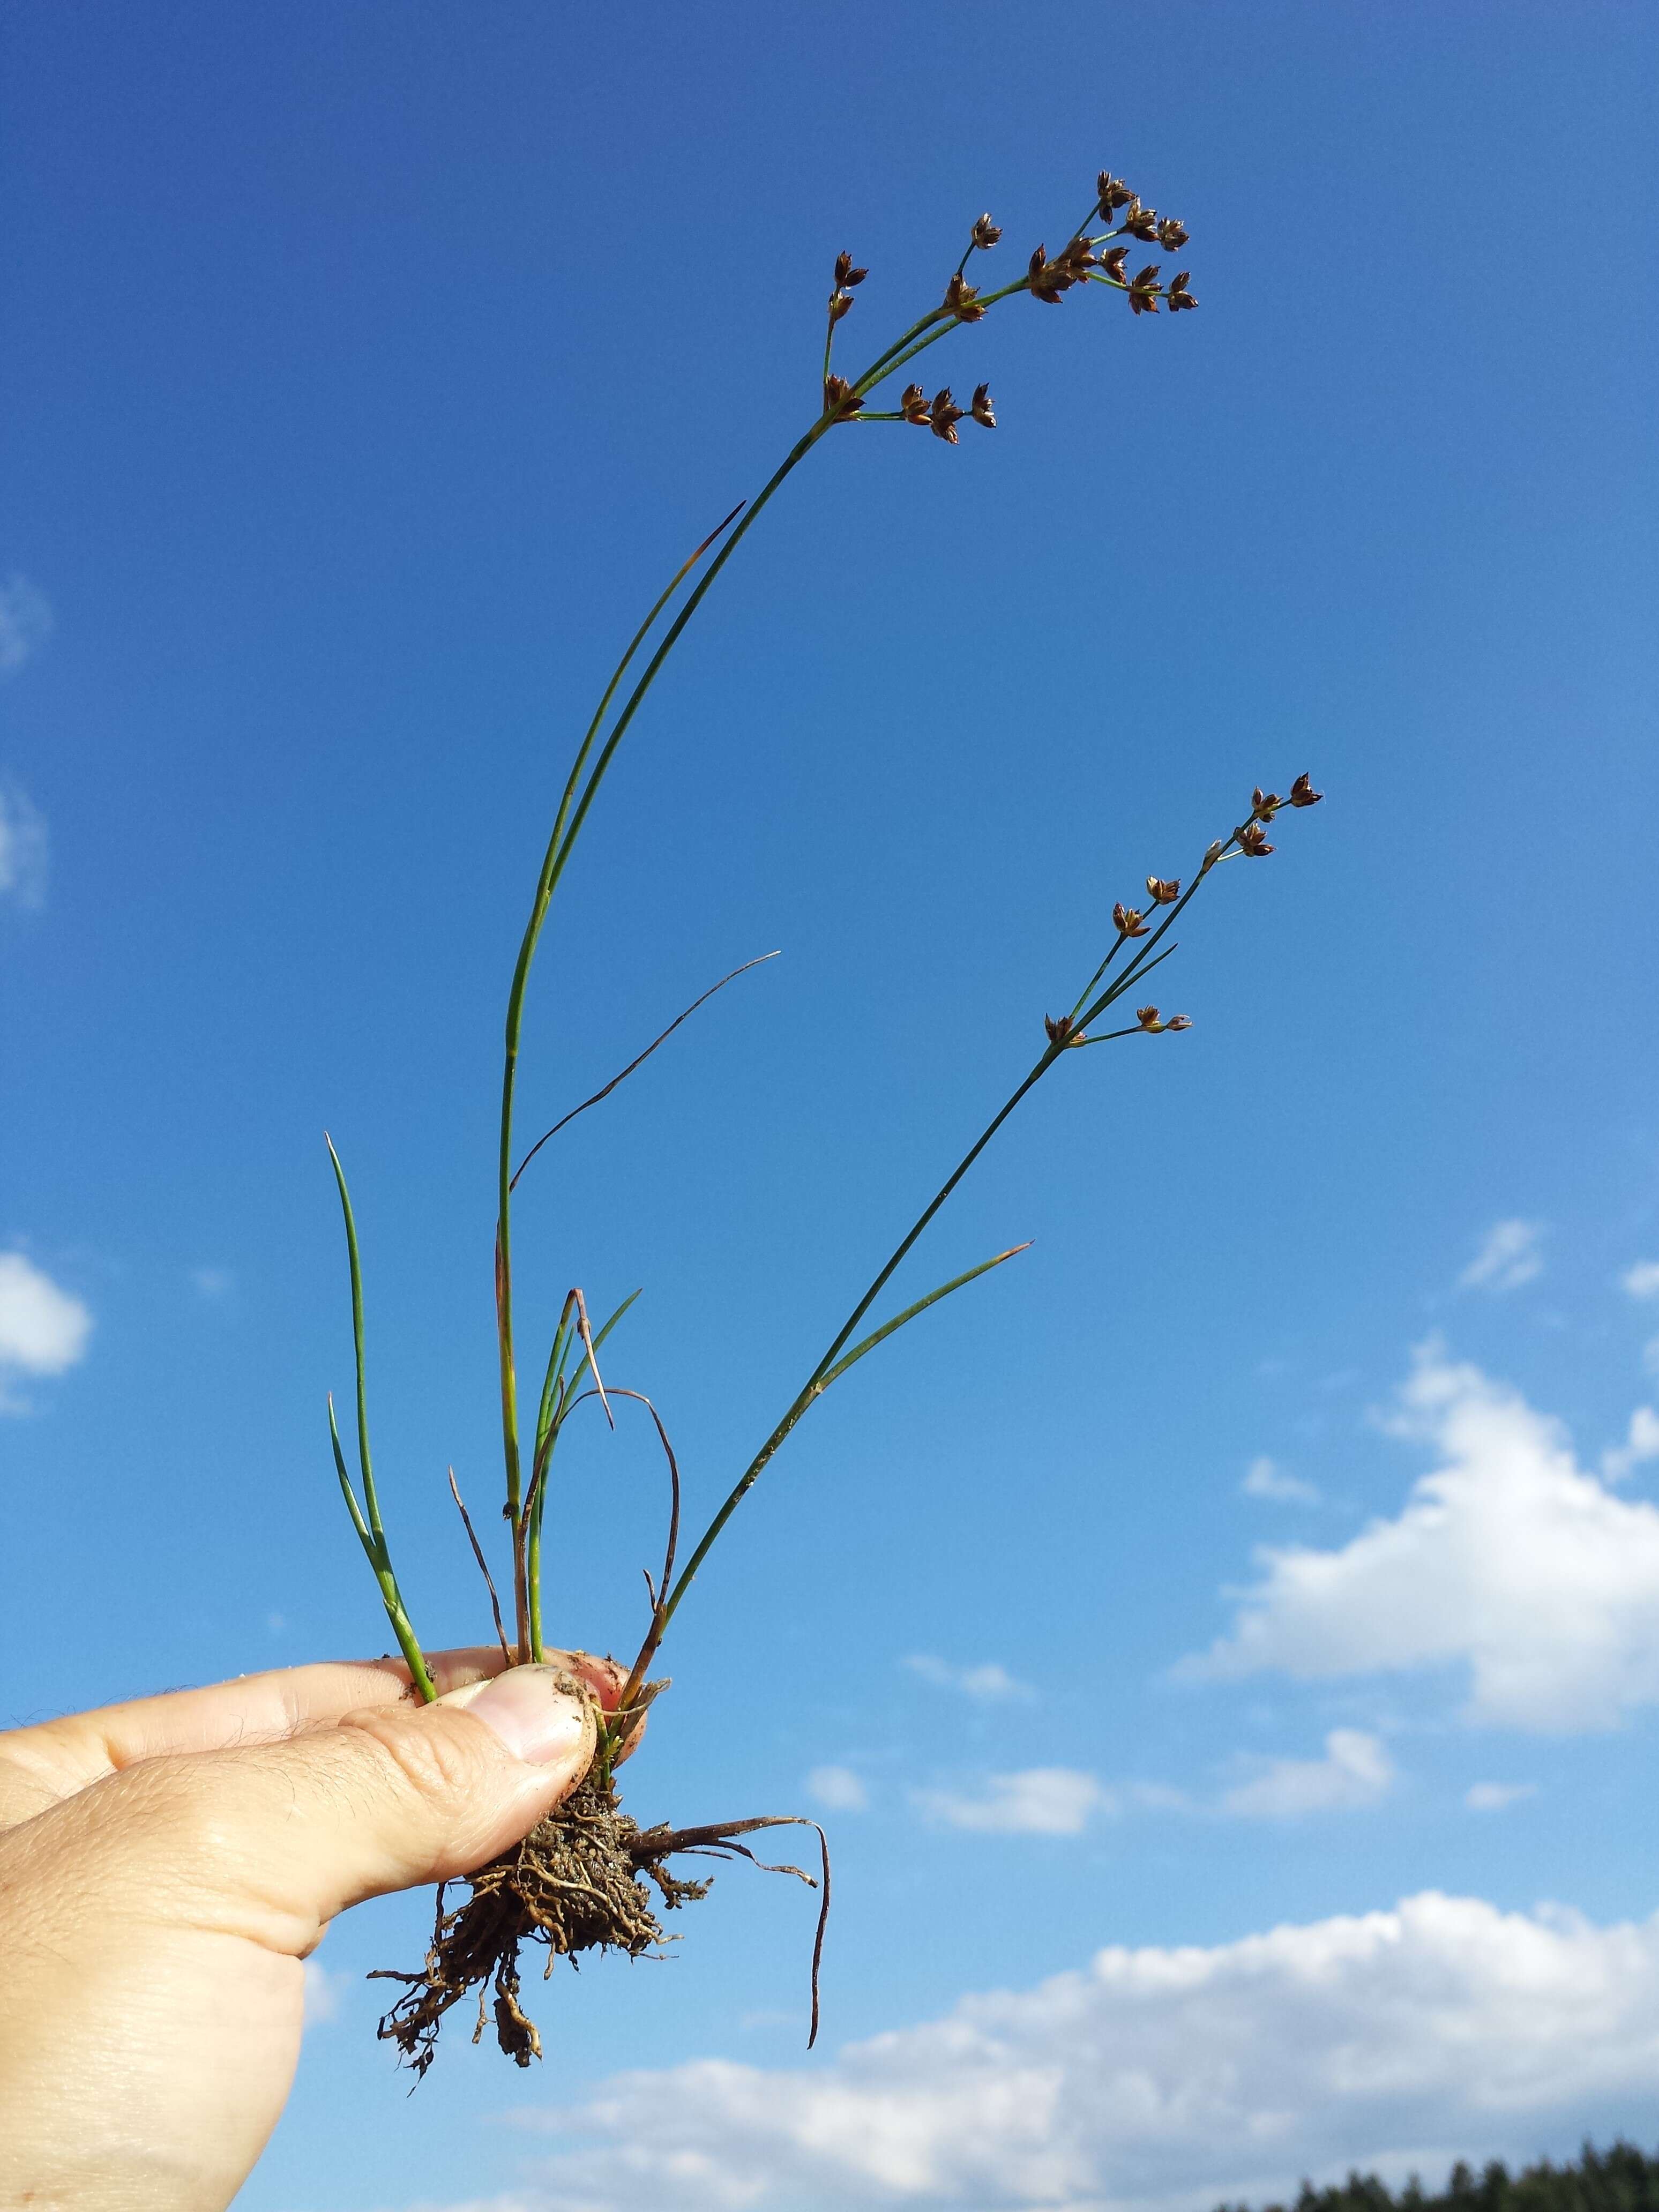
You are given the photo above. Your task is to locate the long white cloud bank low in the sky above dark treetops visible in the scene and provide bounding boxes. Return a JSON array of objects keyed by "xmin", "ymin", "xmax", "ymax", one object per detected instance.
[{"xmin": 493, "ymin": 1891, "xmax": 1659, "ymax": 2212}]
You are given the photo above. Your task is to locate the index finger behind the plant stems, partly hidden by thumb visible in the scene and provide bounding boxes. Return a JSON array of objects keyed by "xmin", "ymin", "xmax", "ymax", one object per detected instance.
[{"xmin": 0, "ymin": 1643, "xmax": 626, "ymax": 1827}]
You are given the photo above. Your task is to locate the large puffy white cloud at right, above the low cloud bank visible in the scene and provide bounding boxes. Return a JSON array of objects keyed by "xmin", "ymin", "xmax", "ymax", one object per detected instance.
[{"xmin": 1181, "ymin": 1347, "xmax": 1659, "ymax": 1730}]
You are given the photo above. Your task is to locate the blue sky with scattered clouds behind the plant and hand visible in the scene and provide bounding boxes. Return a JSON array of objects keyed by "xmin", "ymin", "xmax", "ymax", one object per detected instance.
[{"xmin": 0, "ymin": 0, "xmax": 1659, "ymax": 2212}]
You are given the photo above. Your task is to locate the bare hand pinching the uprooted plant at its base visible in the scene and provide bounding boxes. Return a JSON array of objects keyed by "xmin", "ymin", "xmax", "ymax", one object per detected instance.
[{"xmin": 0, "ymin": 1650, "xmax": 637, "ymax": 2212}]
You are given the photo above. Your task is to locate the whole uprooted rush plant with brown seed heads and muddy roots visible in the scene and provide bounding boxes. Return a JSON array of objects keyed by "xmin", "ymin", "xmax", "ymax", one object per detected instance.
[{"xmin": 330, "ymin": 170, "xmax": 1320, "ymax": 2073}]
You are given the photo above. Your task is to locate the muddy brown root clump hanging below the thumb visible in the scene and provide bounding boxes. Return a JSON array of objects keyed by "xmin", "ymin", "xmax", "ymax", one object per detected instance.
[{"xmin": 369, "ymin": 1772, "xmax": 829, "ymax": 2081}]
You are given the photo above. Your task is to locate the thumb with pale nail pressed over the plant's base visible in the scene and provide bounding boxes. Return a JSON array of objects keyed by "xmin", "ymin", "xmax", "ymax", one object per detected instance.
[{"xmin": 23, "ymin": 1665, "xmax": 597, "ymax": 1957}]
